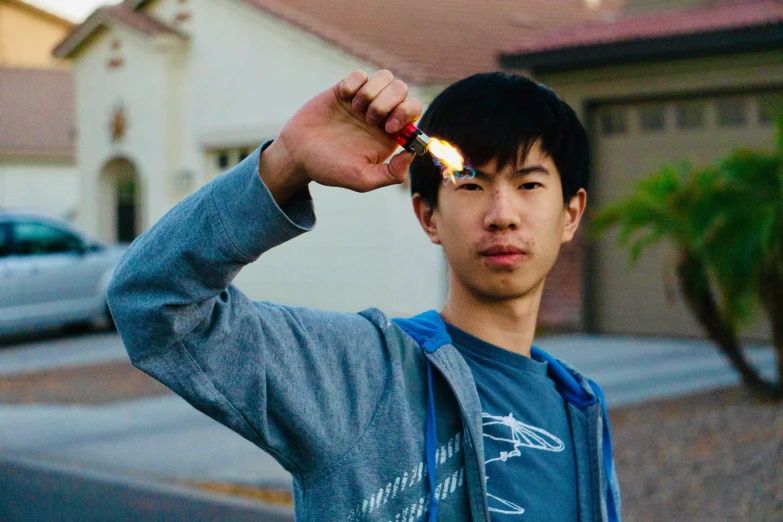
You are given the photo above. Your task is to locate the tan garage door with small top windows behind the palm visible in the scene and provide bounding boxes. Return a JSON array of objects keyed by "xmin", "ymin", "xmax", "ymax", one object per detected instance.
[{"xmin": 588, "ymin": 92, "xmax": 780, "ymax": 339}]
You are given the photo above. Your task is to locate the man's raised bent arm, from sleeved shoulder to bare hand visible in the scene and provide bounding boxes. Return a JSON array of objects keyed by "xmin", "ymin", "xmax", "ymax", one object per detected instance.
[{"xmin": 108, "ymin": 69, "xmax": 420, "ymax": 478}]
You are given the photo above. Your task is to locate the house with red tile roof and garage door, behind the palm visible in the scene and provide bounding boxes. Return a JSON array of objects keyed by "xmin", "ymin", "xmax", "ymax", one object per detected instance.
[{"xmin": 500, "ymin": 0, "xmax": 783, "ymax": 340}]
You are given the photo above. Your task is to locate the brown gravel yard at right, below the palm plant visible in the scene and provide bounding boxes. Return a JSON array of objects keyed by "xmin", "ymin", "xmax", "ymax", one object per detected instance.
[{"xmin": 609, "ymin": 388, "xmax": 783, "ymax": 522}]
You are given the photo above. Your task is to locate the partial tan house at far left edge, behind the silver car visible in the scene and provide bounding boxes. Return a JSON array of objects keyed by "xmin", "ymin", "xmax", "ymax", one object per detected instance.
[{"xmin": 0, "ymin": 0, "xmax": 79, "ymax": 217}]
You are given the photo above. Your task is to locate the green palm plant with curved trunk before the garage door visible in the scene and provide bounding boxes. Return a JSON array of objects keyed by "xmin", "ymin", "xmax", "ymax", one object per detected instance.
[{"xmin": 592, "ymin": 118, "xmax": 783, "ymax": 400}]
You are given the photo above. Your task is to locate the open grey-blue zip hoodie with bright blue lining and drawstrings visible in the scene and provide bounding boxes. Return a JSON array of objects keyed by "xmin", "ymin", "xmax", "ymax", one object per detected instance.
[{"xmin": 108, "ymin": 142, "xmax": 620, "ymax": 522}]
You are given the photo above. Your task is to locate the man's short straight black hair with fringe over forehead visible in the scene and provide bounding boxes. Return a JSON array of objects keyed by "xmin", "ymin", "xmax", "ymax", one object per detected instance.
[{"xmin": 410, "ymin": 72, "xmax": 590, "ymax": 207}]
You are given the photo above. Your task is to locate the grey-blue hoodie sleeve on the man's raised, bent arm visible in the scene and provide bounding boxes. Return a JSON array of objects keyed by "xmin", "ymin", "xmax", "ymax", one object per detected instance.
[{"xmin": 108, "ymin": 142, "xmax": 390, "ymax": 479}]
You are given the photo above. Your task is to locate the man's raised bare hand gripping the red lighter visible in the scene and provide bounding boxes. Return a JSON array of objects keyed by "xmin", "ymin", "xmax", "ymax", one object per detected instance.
[{"xmin": 259, "ymin": 70, "xmax": 422, "ymax": 204}]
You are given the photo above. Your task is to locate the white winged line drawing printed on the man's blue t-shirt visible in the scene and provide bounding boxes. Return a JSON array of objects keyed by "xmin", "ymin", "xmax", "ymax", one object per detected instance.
[{"xmin": 481, "ymin": 413, "xmax": 565, "ymax": 515}]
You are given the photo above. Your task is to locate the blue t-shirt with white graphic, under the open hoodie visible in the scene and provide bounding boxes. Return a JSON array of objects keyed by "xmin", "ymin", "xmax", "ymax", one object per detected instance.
[{"xmin": 446, "ymin": 324, "xmax": 578, "ymax": 522}]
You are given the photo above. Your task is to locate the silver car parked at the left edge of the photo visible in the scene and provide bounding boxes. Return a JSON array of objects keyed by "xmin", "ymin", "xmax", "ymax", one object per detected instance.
[{"xmin": 0, "ymin": 209, "xmax": 127, "ymax": 335}]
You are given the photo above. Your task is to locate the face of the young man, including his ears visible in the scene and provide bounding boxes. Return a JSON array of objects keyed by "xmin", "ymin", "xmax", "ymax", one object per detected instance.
[{"xmin": 415, "ymin": 143, "xmax": 586, "ymax": 301}]
